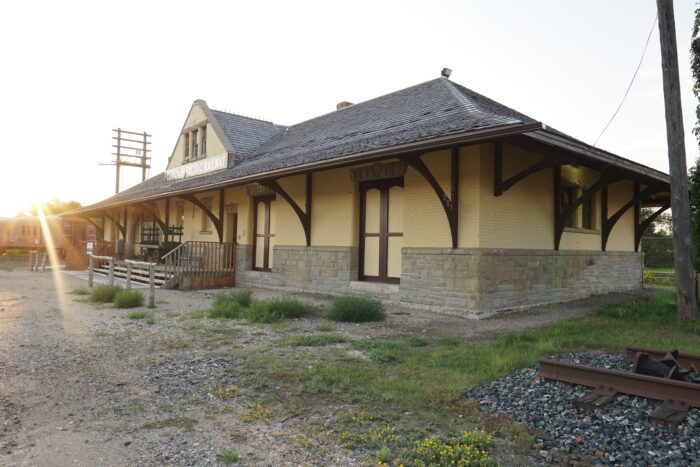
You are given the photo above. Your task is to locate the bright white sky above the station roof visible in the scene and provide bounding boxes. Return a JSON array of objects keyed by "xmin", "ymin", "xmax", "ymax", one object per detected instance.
[{"xmin": 0, "ymin": 0, "xmax": 698, "ymax": 216}]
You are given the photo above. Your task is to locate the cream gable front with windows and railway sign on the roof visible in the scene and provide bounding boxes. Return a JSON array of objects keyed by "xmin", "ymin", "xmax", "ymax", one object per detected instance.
[{"xmin": 166, "ymin": 100, "xmax": 234, "ymax": 180}]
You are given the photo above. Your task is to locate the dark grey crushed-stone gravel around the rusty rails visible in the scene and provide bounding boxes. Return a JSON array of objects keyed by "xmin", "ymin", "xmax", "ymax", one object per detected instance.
[{"xmin": 465, "ymin": 353, "xmax": 700, "ymax": 466}]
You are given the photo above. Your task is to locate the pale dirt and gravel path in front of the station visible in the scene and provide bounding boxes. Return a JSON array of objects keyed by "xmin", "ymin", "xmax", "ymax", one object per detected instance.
[{"xmin": 0, "ymin": 269, "xmax": 652, "ymax": 466}]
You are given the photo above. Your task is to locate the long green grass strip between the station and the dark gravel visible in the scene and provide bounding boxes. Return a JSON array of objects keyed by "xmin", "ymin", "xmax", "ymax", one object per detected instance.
[{"xmin": 243, "ymin": 293, "xmax": 700, "ymax": 412}]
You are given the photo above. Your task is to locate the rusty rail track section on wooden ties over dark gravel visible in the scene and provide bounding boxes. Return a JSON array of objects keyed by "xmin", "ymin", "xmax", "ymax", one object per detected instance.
[{"xmin": 539, "ymin": 347, "xmax": 700, "ymax": 427}]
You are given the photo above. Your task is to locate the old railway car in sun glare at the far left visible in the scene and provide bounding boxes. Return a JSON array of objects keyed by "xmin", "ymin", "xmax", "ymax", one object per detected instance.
[{"xmin": 0, "ymin": 216, "xmax": 97, "ymax": 256}]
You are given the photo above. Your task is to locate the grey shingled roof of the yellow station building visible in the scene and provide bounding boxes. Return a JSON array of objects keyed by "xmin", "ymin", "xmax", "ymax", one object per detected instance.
[{"xmin": 74, "ymin": 78, "xmax": 664, "ymax": 211}]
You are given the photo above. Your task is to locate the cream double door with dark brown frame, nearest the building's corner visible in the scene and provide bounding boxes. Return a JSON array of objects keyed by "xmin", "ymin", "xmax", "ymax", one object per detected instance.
[{"xmin": 360, "ymin": 178, "xmax": 404, "ymax": 283}]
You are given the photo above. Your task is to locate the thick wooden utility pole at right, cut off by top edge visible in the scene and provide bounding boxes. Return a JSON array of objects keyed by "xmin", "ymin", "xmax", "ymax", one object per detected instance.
[{"xmin": 656, "ymin": 0, "xmax": 697, "ymax": 321}]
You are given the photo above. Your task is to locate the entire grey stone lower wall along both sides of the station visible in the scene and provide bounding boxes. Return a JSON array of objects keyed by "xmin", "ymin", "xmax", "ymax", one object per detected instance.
[{"xmin": 236, "ymin": 245, "xmax": 642, "ymax": 318}]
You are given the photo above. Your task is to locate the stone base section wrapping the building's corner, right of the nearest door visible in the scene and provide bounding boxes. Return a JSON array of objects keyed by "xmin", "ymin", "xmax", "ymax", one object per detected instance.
[{"xmin": 401, "ymin": 248, "xmax": 642, "ymax": 317}]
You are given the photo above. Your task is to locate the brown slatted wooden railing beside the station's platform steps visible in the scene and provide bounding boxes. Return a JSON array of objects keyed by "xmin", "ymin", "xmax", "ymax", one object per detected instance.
[{"xmin": 161, "ymin": 241, "xmax": 236, "ymax": 277}]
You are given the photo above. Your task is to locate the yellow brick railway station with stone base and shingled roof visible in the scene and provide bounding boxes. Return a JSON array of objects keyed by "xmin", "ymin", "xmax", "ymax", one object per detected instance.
[{"xmin": 71, "ymin": 77, "xmax": 670, "ymax": 316}]
